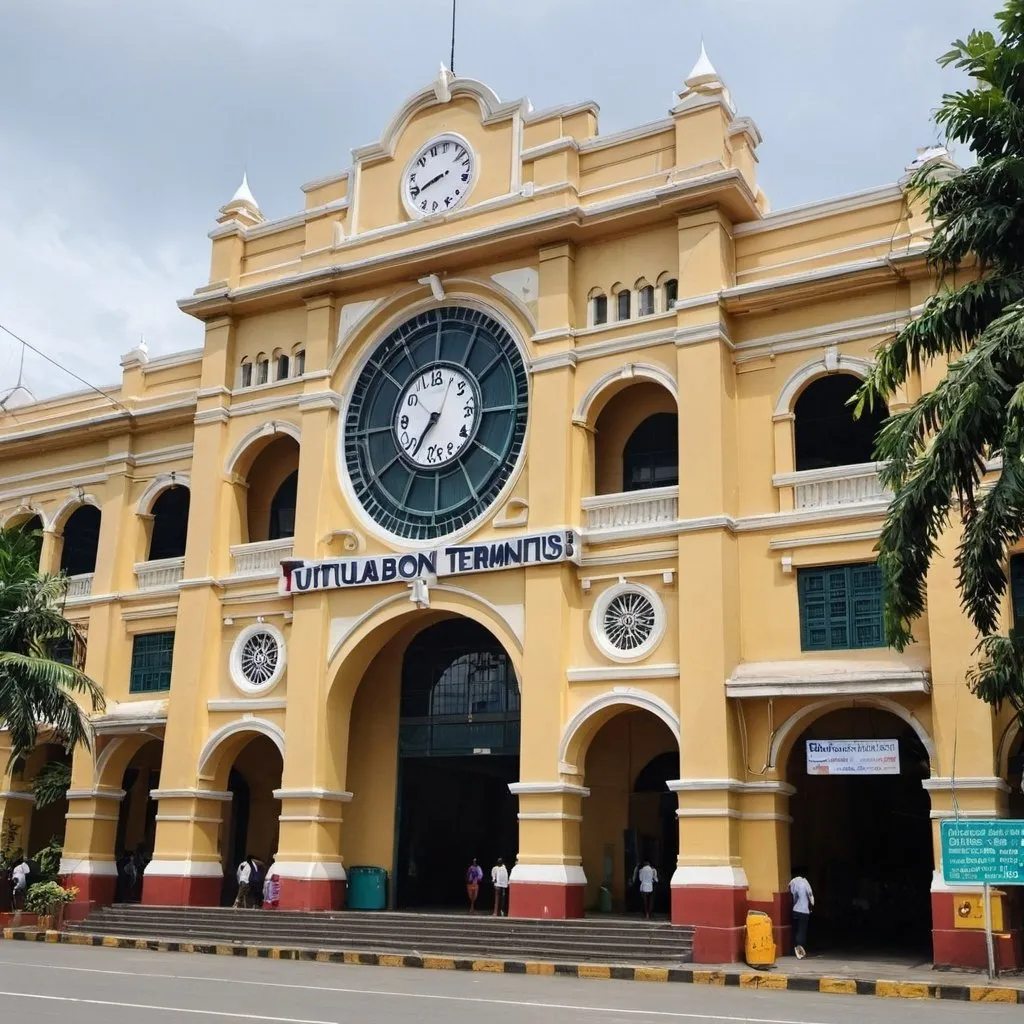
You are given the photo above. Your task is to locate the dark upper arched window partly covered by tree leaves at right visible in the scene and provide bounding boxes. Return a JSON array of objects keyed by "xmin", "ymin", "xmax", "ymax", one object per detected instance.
[{"xmin": 793, "ymin": 373, "xmax": 889, "ymax": 472}]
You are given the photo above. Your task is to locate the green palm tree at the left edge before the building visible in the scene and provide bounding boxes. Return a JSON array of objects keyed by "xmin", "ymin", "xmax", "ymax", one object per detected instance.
[{"xmin": 0, "ymin": 527, "xmax": 103, "ymax": 764}]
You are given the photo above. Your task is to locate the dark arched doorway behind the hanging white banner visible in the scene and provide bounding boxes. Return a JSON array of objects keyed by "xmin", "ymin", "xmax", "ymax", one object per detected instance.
[{"xmin": 786, "ymin": 708, "xmax": 934, "ymax": 956}]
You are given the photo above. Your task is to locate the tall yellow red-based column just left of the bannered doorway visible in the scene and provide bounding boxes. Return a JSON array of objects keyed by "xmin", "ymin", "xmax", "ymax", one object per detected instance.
[{"xmin": 670, "ymin": 210, "xmax": 748, "ymax": 963}]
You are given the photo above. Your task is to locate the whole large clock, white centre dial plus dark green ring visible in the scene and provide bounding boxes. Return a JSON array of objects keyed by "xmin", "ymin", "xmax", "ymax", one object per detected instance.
[{"xmin": 343, "ymin": 306, "xmax": 528, "ymax": 541}]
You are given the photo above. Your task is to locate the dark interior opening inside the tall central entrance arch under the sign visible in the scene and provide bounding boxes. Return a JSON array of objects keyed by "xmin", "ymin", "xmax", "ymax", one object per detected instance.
[{"xmin": 393, "ymin": 618, "xmax": 519, "ymax": 908}]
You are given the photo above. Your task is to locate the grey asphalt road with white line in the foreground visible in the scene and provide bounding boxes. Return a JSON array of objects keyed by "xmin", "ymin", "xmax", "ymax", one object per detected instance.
[{"xmin": 0, "ymin": 942, "xmax": 1021, "ymax": 1024}]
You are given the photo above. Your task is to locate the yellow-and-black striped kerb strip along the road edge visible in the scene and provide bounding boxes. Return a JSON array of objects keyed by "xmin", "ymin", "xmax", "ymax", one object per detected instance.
[{"xmin": 0, "ymin": 928, "xmax": 1024, "ymax": 1005}]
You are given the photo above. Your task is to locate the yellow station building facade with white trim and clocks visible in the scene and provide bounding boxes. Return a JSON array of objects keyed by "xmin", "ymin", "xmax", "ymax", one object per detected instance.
[{"xmin": 0, "ymin": 54, "xmax": 1020, "ymax": 963}]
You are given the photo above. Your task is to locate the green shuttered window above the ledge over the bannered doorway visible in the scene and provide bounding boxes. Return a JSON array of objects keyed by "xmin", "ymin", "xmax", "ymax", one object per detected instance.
[{"xmin": 797, "ymin": 562, "xmax": 886, "ymax": 650}]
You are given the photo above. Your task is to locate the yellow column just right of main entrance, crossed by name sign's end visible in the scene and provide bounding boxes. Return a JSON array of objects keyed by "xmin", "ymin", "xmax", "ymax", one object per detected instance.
[{"xmin": 509, "ymin": 243, "xmax": 587, "ymax": 918}]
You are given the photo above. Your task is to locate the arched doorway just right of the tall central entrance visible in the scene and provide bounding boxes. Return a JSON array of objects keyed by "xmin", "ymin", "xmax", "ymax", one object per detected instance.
[{"xmin": 581, "ymin": 709, "xmax": 679, "ymax": 913}]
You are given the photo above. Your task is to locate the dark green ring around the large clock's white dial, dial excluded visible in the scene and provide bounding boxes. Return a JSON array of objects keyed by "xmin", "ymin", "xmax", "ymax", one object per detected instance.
[{"xmin": 342, "ymin": 305, "xmax": 529, "ymax": 542}]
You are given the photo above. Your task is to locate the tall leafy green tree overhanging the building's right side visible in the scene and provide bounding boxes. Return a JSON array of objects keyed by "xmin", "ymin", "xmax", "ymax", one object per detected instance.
[{"xmin": 858, "ymin": 6, "xmax": 1024, "ymax": 721}]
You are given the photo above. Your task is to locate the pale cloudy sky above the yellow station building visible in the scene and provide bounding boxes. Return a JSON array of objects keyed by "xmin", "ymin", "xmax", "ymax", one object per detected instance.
[{"xmin": 0, "ymin": 0, "xmax": 998, "ymax": 394}]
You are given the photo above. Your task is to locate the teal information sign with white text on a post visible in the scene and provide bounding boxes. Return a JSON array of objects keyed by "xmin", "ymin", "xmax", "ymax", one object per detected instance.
[{"xmin": 942, "ymin": 818, "xmax": 1024, "ymax": 886}]
